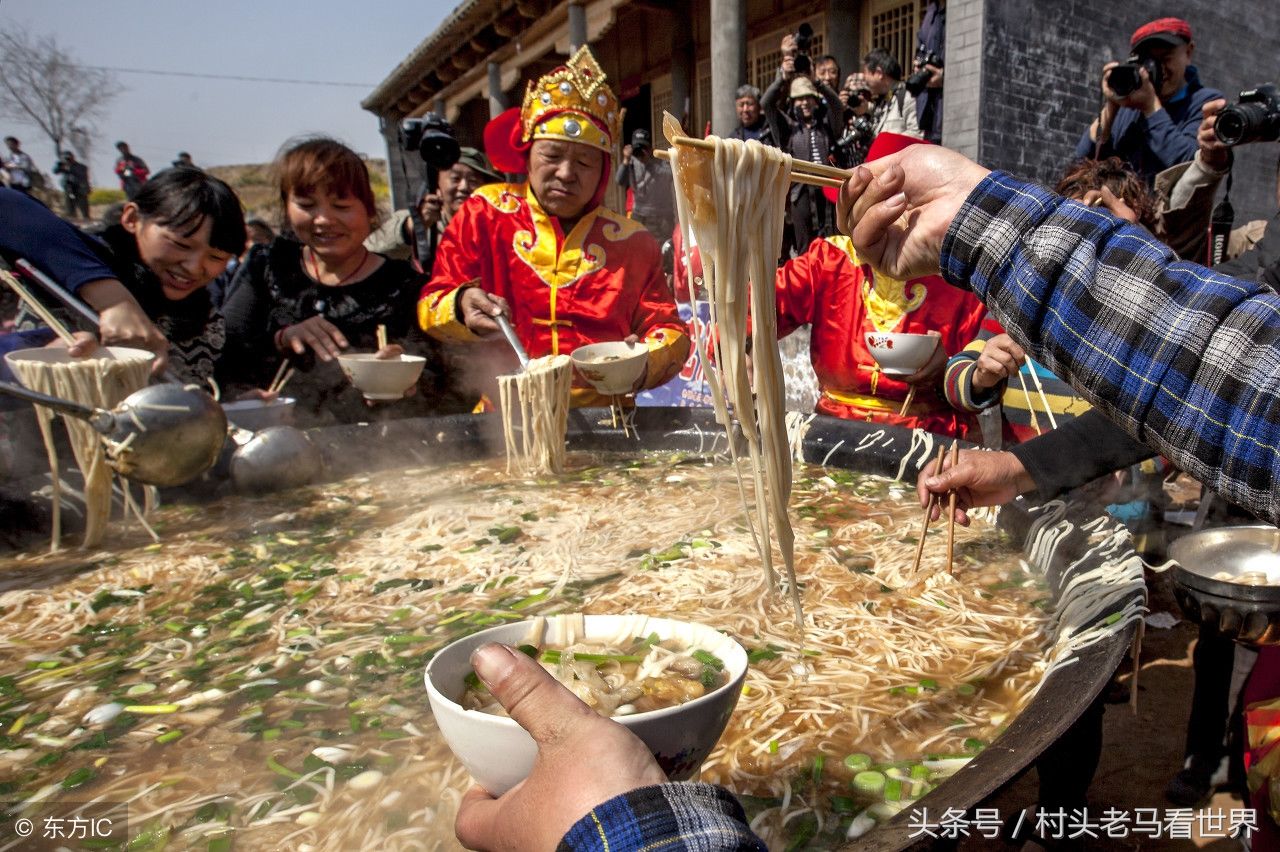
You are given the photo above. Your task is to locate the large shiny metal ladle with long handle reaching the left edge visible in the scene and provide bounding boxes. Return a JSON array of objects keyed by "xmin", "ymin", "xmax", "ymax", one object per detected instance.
[{"xmin": 0, "ymin": 381, "xmax": 227, "ymax": 486}]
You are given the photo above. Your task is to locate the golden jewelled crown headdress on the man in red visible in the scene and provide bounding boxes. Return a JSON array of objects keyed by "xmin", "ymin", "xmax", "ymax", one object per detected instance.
[{"xmin": 520, "ymin": 45, "xmax": 623, "ymax": 152}]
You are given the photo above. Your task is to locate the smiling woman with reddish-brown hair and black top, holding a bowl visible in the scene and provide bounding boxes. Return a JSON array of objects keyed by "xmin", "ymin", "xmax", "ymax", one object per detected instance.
[{"xmin": 220, "ymin": 138, "xmax": 463, "ymax": 425}]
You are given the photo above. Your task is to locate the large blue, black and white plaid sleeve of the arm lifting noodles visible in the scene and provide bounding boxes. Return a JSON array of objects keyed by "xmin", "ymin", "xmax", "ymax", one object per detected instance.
[{"xmin": 942, "ymin": 171, "xmax": 1280, "ymax": 523}]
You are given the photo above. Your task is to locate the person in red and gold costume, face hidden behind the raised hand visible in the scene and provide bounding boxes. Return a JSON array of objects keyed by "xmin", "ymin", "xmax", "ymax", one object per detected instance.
[{"xmin": 777, "ymin": 133, "xmax": 986, "ymax": 441}]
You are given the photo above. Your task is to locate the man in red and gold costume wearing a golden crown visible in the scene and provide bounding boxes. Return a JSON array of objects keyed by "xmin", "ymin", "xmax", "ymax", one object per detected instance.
[{"xmin": 417, "ymin": 47, "xmax": 689, "ymax": 406}]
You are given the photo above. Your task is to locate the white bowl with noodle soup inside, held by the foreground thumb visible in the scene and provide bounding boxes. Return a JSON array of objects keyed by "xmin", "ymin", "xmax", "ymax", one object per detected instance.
[{"xmin": 425, "ymin": 615, "xmax": 748, "ymax": 796}]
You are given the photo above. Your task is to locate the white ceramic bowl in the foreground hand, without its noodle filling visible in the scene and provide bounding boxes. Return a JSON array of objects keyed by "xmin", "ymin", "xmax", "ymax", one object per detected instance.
[{"xmin": 425, "ymin": 615, "xmax": 746, "ymax": 796}]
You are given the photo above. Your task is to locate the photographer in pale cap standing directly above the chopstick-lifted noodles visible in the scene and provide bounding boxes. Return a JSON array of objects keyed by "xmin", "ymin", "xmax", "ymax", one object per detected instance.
[{"xmin": 760, "ymin": 30, "xmax": 845, "ymax": 253}]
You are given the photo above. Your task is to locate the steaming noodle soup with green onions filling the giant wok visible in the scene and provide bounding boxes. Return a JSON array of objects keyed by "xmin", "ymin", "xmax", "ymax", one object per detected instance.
[{"xmin": 0, "ymin": 454, "xmax": 1048, "ymax": 849}]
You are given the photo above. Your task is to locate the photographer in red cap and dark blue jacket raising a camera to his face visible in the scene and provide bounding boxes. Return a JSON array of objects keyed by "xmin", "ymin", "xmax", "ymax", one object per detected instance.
[{"xmin": 1075, "ymin": 18, "xmax": 1222, "ymax": 184}]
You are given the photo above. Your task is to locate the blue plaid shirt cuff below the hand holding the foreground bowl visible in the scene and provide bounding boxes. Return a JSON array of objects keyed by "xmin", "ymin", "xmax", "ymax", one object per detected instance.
[{"xmin": 558, "ymin": 783, "xmax": 765, "ymax": 852}]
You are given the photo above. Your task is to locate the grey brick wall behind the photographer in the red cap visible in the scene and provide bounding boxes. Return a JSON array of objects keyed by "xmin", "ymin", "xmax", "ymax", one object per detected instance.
[{"xmin": 972, "ymin": 0, "xmax": 1280, "ymax": 223}]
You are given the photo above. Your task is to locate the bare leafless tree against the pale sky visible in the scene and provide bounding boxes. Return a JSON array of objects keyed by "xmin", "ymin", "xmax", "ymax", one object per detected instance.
[{"xmin": 0, "ymin": 29, "xmax": 120, "ymax": 161}]
